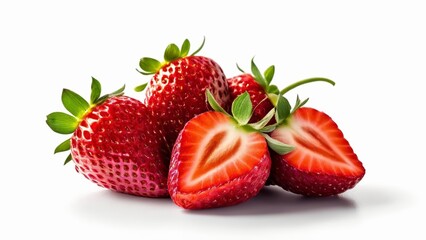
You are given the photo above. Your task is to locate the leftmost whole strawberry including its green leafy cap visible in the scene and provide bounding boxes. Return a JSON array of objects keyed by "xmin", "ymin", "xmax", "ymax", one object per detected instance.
[{"xmin": 46, "ymin": 78, "xmax": 168, "ymax": 197}]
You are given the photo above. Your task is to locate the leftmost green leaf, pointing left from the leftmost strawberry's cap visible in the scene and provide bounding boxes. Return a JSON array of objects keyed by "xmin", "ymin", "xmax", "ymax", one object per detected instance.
[{"xmin": 46, "ymin": 112, "xmax": 78, "ymax": 134}]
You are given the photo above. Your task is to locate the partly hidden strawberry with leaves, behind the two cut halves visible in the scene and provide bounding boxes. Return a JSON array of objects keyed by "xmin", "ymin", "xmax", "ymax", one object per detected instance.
[{"xmin": 227, "ymin": 59, "xmax": 279, "ymax": 123}]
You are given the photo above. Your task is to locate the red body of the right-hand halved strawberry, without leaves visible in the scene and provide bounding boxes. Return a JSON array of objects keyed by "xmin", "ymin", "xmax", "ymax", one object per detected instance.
[{"xmin": 271, "ymin": 107, "xmax": 365, "ymax": 197}]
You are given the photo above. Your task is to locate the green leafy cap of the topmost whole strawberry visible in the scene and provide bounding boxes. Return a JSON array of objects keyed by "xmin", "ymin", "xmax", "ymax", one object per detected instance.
[{"xmin": 136, "ymin": 37, "xmax": 206, "ymax": 75}]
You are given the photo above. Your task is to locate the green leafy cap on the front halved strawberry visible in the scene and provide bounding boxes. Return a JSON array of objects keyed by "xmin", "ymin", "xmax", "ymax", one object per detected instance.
[{"xmin": 206, "ymin": 89, "xmax": 294, "ymax": 155}]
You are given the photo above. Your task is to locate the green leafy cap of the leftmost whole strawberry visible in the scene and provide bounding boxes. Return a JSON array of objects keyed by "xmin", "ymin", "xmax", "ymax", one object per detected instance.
[{"xmin": 46, "ymin": 77, "xmax": 125, "ymax": 165}]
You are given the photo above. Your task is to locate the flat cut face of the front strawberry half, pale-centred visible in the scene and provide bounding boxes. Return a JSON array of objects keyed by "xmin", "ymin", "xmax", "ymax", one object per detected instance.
[{"xmin": 172, "ymin": 112, "xmax": 267, "ymax": 192}]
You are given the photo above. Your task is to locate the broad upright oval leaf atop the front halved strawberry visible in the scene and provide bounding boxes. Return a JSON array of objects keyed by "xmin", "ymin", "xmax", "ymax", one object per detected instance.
[{"xmin": 231, "ymin": 91, "xmax": 253, "ymax": 125}]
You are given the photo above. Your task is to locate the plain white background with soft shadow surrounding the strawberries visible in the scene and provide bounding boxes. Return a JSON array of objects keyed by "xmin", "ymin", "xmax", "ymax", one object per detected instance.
[{"xmin": 0, "ymin": 0, "xmax": 426, "ymax": 239}]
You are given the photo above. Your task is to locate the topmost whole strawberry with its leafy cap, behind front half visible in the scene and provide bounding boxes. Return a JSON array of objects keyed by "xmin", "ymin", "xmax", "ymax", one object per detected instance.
[{"xmin": 136, "ymin": 39, "xmax": 230, "ymax": 151}]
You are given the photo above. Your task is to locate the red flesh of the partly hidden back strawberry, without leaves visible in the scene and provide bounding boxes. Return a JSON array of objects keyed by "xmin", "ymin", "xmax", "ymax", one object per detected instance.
[{"xmin": 227, "ymin": 73, "xmax": 274, "ymax": 123}]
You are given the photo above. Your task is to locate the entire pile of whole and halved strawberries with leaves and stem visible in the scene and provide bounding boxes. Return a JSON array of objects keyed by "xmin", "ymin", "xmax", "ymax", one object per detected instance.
[{"xmin": 46, "ymin": 40, "xmax": 365, "ymax": 209}]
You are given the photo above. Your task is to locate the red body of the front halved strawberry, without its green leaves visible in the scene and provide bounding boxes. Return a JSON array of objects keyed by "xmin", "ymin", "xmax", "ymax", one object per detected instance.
[{"xmin": 168, "ymin": 111, "xmax": 271, "ymax": 209}]
